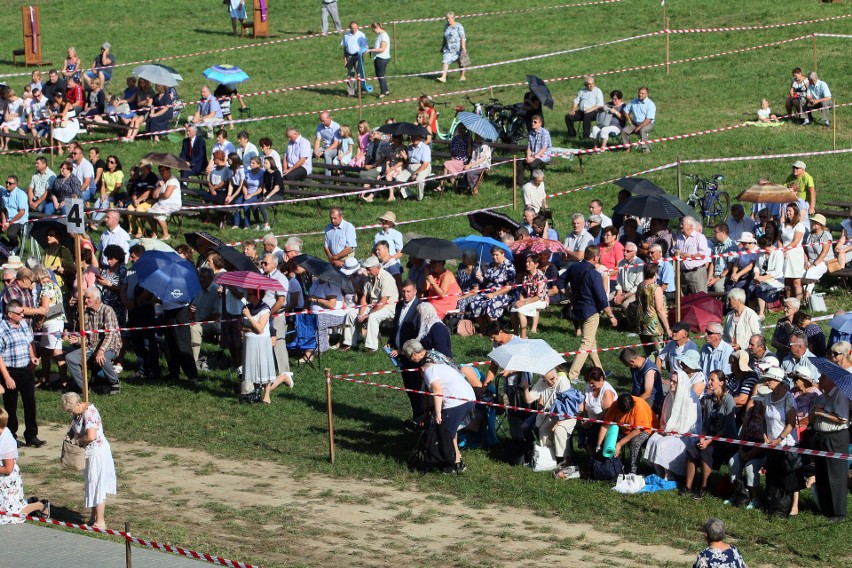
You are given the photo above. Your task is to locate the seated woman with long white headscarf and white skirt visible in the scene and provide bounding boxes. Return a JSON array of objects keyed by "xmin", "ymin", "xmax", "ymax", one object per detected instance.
[{"xmin": 645, "ymin": 364, "xmax": 701, "ymax": 479}]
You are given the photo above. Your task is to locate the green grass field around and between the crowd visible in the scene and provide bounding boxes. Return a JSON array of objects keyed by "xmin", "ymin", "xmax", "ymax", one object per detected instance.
[{"xmin": 0, "ymin": 0, "xmax": 852, "ymax": 566}]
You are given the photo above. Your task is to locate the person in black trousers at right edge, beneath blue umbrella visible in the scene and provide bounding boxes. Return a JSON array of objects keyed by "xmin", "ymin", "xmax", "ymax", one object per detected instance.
[{"xmin": 810, "ymin": 366, "xmax": 849, "ymax": 522}]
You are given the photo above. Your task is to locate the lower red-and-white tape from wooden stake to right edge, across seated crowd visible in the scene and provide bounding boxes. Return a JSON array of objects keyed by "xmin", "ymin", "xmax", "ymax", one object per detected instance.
[{"xmin": 331, "ymin": 368, "xmax": 852, "ymax": 461}]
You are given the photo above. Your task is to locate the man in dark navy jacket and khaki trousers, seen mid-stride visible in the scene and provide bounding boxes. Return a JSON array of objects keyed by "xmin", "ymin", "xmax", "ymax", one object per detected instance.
[{"xmin": 565, "ymin": 245, "xmax": 618, "ymax": 381}]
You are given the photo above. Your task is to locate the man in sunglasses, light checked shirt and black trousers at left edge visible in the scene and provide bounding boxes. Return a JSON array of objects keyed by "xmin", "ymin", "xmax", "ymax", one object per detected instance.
[{"xmin": 0, "ymin": 300, "xmax": 44, "ymax": 448}]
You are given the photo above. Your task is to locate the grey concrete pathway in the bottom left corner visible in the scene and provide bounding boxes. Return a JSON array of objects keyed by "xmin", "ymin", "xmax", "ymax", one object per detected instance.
[{"xmin": 0, "ymin": 522, "xmax": 204, "ymax": 568}]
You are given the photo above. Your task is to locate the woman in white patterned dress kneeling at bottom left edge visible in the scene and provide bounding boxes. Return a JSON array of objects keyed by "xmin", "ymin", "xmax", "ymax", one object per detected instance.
[{"xmin": 0, "ymin": 408, "xmax": 50, "ymax": 525}]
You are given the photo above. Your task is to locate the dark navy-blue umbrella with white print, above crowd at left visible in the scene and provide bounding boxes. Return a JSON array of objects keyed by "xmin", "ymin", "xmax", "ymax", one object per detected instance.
[{"xmin": 133, "ymin": 250, "xmax": 201, "ymax": 309}]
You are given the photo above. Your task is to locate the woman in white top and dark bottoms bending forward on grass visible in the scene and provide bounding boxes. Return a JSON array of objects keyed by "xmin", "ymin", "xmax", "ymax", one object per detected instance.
[{"xmin": 402, "ymin": 339, "xmax": 476, "ymax": 473}]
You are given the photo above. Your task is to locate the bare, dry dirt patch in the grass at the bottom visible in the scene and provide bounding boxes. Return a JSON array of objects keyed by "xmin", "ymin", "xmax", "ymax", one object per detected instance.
[{"xmin": 25, "ymin": 426, "xmax": 699, "ymax": 568}]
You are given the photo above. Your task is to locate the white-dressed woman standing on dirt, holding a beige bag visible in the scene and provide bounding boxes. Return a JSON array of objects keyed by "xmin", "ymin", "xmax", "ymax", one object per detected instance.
[{"xmin": 62, "ymin": 392, "xmax": 116, "ymax": 530}]
